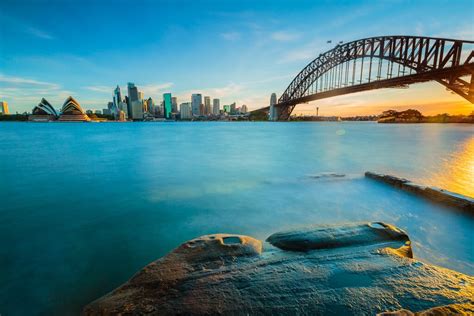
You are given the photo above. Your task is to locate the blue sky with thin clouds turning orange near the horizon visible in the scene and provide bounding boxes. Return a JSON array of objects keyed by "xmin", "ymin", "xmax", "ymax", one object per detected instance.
[{"xmin": 0, "ymin": 0, "xmax": 474, "ymax": 116}]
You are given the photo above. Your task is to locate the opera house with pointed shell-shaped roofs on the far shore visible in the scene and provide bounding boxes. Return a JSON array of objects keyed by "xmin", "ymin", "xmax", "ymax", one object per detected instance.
[{"xmin": 28, "ymin": 96, "xmax": 91, "ymax": 122}]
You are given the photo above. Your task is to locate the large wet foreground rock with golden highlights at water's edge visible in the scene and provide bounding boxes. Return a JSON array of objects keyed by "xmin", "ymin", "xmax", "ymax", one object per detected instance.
[{"xmin": 84, "ymin": 223, "xmax": 474, "ymax": 315}]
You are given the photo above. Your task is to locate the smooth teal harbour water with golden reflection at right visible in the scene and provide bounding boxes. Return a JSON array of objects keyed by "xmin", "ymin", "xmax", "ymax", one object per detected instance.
[{"xmin": 0, "ymin": 123, "xmax": 474, "ymax": 315}]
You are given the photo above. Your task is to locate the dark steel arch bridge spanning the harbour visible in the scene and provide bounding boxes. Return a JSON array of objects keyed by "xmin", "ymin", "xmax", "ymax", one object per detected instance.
[{"xmin": 274, "ymin": 35, "xmax": 474, "ymax": 120}]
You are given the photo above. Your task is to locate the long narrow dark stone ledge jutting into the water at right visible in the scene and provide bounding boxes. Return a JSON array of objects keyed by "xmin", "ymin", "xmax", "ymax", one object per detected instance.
[{"xmin": 365, "ymin": 171, "xmax": 474, "ymax": 215}]
